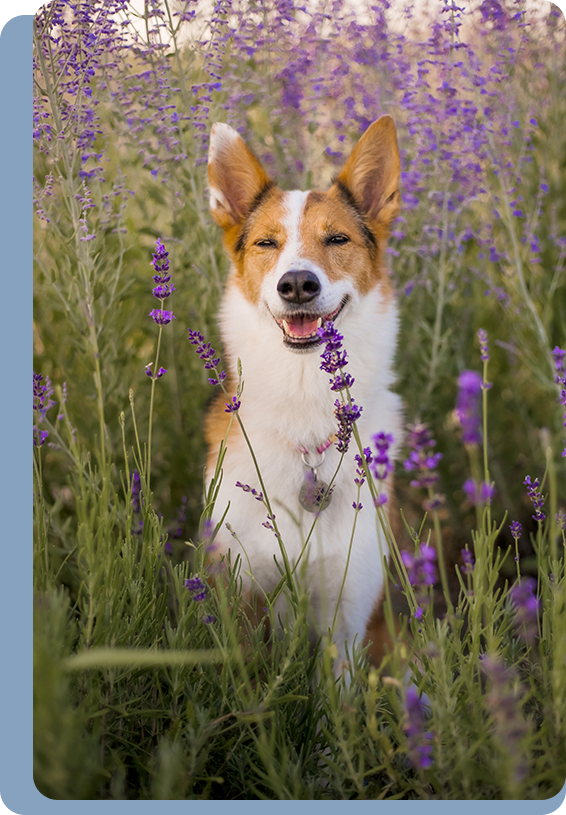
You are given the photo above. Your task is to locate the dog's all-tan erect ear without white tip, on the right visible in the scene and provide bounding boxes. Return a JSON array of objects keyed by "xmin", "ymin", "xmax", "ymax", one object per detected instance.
[{"xmin": 336, "ymin": 116, "xmax": 401, "ymax": 224}]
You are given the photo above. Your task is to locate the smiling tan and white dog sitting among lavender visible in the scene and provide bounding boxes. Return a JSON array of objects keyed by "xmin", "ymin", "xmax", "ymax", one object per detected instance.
[{"xmin": 205, "ymin": 115, "xmax": 402, "ymax": 675}]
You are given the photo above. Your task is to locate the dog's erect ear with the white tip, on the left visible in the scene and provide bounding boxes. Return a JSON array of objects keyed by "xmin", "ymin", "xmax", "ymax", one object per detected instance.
[{"xmin": 208, "ymin": 122, "xmax": 271, "ymax": 229}]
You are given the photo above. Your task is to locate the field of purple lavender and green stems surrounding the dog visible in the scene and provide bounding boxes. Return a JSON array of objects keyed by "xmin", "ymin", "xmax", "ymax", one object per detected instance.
[{"xmin": 33, "ymin": 0, "xmax": 566, "ymax": 811}]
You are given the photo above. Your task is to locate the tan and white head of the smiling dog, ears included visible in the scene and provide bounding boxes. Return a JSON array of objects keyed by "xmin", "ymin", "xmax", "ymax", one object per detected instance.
[{"xmin": 208, "ymin": 116, "xmax": 401, "ymax": 351}]
